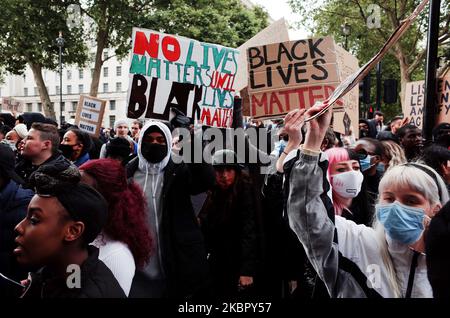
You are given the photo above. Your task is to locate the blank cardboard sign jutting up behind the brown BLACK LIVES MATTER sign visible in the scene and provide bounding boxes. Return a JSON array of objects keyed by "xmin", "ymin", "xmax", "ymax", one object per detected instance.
[{"xmin": 235, "ymin": 18, "xmax": 289, "ymax": 95}]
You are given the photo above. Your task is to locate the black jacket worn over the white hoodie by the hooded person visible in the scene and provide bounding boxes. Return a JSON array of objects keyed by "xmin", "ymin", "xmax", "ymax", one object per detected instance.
[{"xmin": 127, "ymin": 157, "xmax": 215, "ymax": 297}]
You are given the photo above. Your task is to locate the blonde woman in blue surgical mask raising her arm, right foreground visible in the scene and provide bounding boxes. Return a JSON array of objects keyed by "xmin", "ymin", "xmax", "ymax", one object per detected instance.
[{"xmin": 285, "ymin": 105, "xmax": 449, "ymax": 298}]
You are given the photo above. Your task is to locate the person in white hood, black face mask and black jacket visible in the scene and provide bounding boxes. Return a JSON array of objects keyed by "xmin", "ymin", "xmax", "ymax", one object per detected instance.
[{"xmin": 127, "ymin": 121, "xmax": 215, "ymax": 297}]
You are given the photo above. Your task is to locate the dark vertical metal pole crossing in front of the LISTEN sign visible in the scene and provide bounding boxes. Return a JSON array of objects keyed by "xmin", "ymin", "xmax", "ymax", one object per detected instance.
[{"xmin": 422, "ymin": 0, "xmax": 441, "ymax": 144}]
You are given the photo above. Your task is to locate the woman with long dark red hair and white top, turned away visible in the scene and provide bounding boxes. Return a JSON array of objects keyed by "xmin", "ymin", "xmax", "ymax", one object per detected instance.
[{"xmin": 80, "ymin": 159, "xmax": 152, "ymax": 296}]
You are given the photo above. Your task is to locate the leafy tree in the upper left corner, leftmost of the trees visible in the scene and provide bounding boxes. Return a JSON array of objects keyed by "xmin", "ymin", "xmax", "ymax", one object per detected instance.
[{"xmin": 0, "ymin": 0, "xmax": 87, "ymax": 120}]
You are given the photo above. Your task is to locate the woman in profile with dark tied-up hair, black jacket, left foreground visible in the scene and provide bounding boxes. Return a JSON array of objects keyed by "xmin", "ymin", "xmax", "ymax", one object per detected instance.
[{"xmin": 14, "ymin": 161, "xmax": 125, "ymax": 298}]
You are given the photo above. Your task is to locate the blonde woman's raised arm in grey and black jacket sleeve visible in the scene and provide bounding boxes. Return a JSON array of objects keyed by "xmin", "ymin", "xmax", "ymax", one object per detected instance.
[{"xmin": 286, "ymin": 106, "xmax": 339, "ymax": 297}]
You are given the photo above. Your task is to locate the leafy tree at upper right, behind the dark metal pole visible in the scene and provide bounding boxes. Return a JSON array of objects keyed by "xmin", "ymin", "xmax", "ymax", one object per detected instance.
[{"xmin": 289, "ymin": 0, "xmax": 450, "ymax": 119}]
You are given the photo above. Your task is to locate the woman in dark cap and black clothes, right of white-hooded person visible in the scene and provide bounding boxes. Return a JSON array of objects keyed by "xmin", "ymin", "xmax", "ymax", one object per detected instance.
[{"xmin": 199, "ymin": 150, "xmax": 258, "ymax": 296}]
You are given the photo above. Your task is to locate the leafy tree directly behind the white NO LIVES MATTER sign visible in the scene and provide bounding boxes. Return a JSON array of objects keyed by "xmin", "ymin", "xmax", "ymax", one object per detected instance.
[{"xmin": 74, "ymin": 0, "xmax": 267, "ymax": 96}]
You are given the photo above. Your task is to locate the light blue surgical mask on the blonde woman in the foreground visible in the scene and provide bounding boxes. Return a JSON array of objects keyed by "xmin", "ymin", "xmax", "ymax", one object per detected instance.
[{"xmin": 375, "ymin": 201, "xmax": 425, "ymax": 245}]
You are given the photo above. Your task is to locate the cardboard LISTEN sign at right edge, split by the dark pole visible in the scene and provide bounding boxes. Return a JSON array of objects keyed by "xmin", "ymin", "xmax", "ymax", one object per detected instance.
[{"xmin": 402, "ymin": 76, "xmax": 450, "ymax": 129}]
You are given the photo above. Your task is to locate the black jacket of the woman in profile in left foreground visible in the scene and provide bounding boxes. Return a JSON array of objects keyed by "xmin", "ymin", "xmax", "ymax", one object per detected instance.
[{"xmin": 22, "ymin": 246, "xmax": 126, "ymax": 298}]
